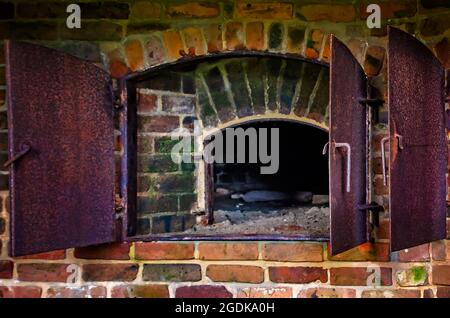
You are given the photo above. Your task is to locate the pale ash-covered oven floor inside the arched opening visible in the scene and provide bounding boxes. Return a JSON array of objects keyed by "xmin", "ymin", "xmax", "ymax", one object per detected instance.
[{"xmin": 184, "ymin": 199, "xmax": 330, "ymax": 237}]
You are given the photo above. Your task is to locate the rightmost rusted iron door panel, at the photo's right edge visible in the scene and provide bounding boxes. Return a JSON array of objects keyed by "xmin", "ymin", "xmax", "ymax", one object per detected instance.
[{"xmin": 388, "ymin": 27, "xmax": 447, "ymax": 251}]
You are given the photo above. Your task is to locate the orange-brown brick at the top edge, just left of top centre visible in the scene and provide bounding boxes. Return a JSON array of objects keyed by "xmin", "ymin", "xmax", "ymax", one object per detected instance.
[{"xmin": 166, "ymin": 2, "xmax": 220, "ymax": 18}]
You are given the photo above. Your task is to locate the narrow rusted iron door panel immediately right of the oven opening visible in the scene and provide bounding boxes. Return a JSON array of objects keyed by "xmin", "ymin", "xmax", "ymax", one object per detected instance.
[{"xmin": 328, "ymin": 36, "xmax": 367, "ymax": 255}]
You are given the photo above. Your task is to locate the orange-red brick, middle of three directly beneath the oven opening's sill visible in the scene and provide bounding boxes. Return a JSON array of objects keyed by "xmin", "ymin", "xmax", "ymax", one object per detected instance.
[{"xmin": 198, "ymin": 243, "xmax": 258, "ymax": 261}]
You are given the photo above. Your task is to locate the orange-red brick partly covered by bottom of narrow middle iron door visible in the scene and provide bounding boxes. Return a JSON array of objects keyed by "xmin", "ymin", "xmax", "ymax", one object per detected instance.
[{"xmin": 328, "ymin": 243, "xmax": 390, "ymax": 262}]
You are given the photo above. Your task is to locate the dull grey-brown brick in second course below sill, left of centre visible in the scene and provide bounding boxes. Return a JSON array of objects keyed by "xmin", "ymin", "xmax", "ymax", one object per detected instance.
[{"xmin": 142, "ymin": 264, "xmax": 202, "ymax": 282}]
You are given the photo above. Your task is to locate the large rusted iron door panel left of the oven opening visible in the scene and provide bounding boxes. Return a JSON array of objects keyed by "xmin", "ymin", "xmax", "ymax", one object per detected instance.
[{"xmin": 6, "ymin": 42, "xmax": 115, "ymax": 256}]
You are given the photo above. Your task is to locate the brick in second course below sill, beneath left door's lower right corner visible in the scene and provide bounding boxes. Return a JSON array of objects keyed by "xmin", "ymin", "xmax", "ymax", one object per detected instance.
[{"xmin": 83, "ymin": 264, "xmax": 139, "ymax": 282}]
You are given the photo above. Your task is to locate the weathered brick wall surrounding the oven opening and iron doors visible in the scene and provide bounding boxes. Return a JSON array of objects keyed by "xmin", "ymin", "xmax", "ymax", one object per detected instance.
[{"xmin": 0, "ymin": 0, "xmax": 450, "ymax": 297}]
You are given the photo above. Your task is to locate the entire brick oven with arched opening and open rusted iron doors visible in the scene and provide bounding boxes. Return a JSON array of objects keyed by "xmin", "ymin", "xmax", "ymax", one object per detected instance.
[{"xmin": 0, "ymin": 0, "xmax": 450, "ymax": 297}]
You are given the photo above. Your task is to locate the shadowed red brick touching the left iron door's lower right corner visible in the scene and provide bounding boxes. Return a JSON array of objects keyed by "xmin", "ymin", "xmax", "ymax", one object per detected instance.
[{"xmin": 75, "ymin": 243, "xmax": 131, "ymax": 260}]
